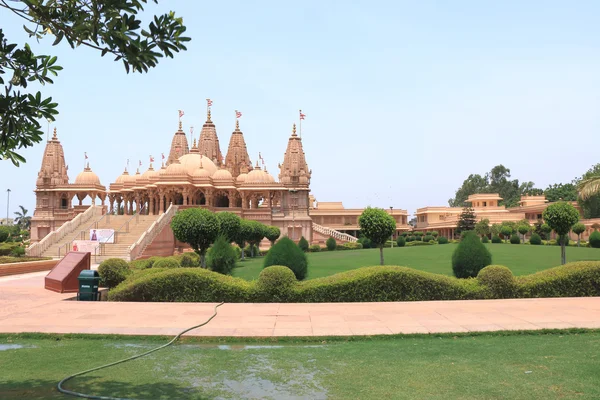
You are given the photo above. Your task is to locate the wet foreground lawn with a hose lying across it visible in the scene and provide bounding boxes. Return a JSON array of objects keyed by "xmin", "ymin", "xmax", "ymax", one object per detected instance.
[{"xmin": 0, "ymin": 331, "xmax": 600, "ymax": 400}]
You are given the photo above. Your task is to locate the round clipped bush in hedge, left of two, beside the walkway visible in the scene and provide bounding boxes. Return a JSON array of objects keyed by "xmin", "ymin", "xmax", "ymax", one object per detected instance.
[{"xmin": 256, "ymin": 265, "xmax": 296, "ymax": 303}]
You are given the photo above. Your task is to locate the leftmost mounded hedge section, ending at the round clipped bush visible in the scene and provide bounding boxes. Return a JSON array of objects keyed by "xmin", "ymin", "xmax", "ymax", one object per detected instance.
[{"xmin": 108, "ymin": 268, "xmax": 253, "ymax": 303}]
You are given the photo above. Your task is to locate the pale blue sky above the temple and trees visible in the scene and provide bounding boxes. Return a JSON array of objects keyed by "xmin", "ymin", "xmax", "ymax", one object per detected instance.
[{"xmin": 0, "ymin": 0, "xmax": 600, "ymax": 217}]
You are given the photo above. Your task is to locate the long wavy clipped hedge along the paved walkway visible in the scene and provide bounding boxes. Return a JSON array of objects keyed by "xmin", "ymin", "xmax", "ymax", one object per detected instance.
[{"xmin": 109, "ymin": 261, "xmax": 600, "ymax": 303}]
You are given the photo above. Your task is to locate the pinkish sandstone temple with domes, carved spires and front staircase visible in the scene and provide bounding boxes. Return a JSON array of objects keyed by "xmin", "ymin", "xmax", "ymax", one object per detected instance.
[{"xmin": 28, "ymin": 109, "xmax": 409, "ymax": 258}]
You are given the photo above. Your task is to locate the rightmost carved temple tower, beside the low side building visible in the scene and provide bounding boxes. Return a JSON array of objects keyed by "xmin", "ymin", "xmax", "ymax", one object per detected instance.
[{"xmin": 279, "ymin": 124, "xmax": 312, "ymax": 243}]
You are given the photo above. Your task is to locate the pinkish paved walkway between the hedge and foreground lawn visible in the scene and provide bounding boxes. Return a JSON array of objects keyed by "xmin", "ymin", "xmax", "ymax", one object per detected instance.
[{"xmin": 0, "ymin": 272, "xmax": 600, "ymax": 336}]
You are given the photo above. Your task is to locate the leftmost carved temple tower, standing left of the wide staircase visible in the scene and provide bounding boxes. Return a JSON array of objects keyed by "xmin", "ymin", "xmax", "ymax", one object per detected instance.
[{"xmin": 31, "ymin": 128, "xmax": 74, "ymax": 242}]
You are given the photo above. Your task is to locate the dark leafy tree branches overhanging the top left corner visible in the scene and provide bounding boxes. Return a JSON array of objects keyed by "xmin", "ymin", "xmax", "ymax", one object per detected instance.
[{"xmin": 0, "ymin": 0, "xmax": 190, "ymax": 165}]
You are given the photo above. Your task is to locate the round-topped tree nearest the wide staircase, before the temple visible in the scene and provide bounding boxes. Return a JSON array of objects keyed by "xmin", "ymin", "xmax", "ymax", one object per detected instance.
[{"xmin": 171, "ymin": 208, "xmax": 220, "ymax": 268}]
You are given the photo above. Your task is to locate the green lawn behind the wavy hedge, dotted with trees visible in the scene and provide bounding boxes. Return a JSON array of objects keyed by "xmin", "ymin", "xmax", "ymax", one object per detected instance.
[{"xmin": 233, "ymin": 244, "xmax": 600, "ymax": 280}]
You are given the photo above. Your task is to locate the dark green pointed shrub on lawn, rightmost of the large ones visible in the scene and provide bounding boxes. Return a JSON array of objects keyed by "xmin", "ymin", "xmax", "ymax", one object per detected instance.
[{"xmin": 452, "ymin": 231, "xmax": 492, "ymax": 278}]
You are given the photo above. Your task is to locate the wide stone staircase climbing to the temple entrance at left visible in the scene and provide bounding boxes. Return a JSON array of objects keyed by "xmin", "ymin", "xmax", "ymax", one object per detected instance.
[{"xmin": 42, "ymin": 215, "xmax": 159, "ymax": 263}]
